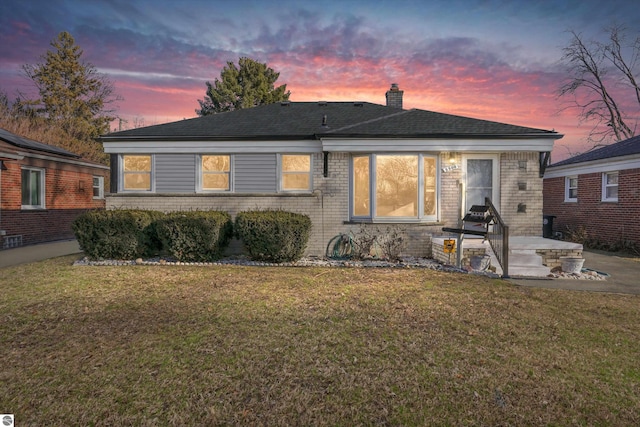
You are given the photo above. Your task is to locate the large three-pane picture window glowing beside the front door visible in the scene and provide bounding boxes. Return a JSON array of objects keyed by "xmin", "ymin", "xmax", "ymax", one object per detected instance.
[{"xmin": 351, "ymin": 154, "xmax": 437, "ymax": 220}]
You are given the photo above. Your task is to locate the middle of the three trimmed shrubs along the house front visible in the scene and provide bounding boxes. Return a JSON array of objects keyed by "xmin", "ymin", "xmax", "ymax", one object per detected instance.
[{"xmin": 155, "ymin": 211, "xmax": 233, "ymax": 262}]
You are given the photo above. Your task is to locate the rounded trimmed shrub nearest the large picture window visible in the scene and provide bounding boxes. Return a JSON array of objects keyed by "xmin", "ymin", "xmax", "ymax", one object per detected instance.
[{"xmin": 235, "ymin": 210, "xmax": 311, "ymax": 262}]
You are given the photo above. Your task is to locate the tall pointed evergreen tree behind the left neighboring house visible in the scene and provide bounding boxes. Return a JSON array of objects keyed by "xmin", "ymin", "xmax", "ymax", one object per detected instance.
[{"xmin": 21, "ymin": 31, "xmax": 120, "ymax": 140}]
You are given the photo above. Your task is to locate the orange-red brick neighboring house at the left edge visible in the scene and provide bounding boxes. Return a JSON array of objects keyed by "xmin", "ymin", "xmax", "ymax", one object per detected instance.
[{"xmin": 0, "ymin": 129, "xmax": 109, "ymax": 249}]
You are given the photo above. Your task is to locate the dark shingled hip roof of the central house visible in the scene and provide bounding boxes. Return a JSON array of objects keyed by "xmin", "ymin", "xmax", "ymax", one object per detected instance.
[{"xmin": 101, "ymin": 102, "xmax": 562, "ymax": 141}]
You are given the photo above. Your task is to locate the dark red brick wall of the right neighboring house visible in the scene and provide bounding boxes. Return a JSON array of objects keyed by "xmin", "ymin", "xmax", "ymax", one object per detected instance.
[{"xmin": 544, "ymin": 169, "xmax": 640, "ymax": 244}]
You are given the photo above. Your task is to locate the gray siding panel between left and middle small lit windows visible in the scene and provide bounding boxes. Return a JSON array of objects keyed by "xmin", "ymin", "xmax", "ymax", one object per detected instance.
[{"xmin": 155, "ymin": 154, "xmax": 196, "ymax": 193}]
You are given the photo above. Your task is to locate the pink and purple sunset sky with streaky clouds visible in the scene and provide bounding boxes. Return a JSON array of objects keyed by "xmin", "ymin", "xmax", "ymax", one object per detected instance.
[{"xmin": 0, "ymin": 0, "xmax": 640, "ymax": 161}]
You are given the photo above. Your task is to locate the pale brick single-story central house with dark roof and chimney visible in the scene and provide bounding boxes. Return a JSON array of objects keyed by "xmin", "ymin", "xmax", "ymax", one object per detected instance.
[{"xmin": 101, "ymin": 84, "xmax": 580, "ymax": 278}]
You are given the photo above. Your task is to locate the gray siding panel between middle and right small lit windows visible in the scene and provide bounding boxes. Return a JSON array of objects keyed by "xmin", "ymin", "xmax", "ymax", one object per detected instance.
[{"xmin": 234, "ymin": 154, "xmax": 278, "ymax": 193}]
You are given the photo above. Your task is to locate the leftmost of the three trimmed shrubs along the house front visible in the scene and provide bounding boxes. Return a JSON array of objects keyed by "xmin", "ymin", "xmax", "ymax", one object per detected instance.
[{"xmin": 72, "ymin": 210, "xmax": 164, "ymax": 259}]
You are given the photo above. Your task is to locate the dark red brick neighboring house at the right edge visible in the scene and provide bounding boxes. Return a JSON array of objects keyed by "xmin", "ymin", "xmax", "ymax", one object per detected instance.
[{"xmin": 544, "ymin": 136, "xmax": 640, "ymax": 248}]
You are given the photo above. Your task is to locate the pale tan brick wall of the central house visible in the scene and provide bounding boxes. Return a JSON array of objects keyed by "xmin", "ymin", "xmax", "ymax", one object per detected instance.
[{"xmin": 107, "ymin": 153, "xmax": 542, "ymax": 257}]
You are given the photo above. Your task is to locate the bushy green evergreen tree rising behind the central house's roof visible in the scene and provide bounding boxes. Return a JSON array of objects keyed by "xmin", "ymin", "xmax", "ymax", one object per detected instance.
[{"xmin": 196, "ymin": 57, "xmax": 291, "ymax": 116}]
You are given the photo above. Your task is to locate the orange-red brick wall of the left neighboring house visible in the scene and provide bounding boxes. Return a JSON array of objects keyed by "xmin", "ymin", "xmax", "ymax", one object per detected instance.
[{"xmin": 0, "ymin": 158, "xmax": 109, "ymax": 249}]
